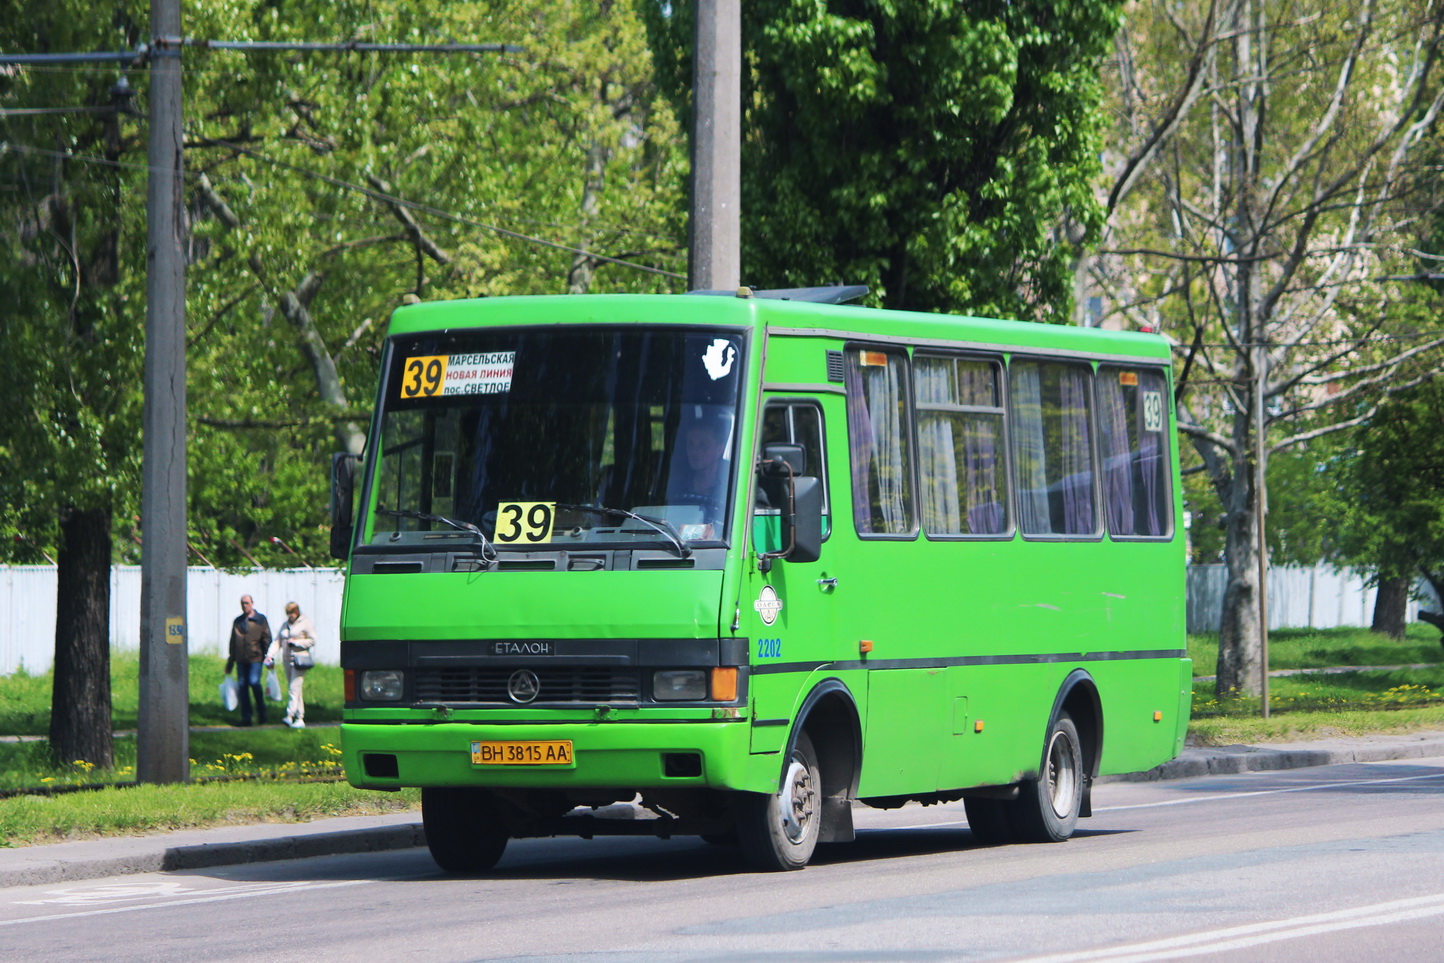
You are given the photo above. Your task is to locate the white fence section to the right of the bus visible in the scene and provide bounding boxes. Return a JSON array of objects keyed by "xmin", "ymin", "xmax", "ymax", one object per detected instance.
[{"xmin": 1188, "ymin": 565, "xmax": 1419, "ymax": 632}]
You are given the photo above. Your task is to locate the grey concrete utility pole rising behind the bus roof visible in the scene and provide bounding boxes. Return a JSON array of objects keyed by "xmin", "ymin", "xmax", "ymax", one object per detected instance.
[{"xmin": 687, "ymin": 0, "xmax": 742, "ymax": 290}]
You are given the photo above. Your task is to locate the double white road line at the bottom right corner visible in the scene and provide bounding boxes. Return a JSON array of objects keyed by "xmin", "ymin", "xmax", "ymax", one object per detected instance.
[{"xmin": 1017, "ymin": 894, "xmax": 1444, "ymax": 963}]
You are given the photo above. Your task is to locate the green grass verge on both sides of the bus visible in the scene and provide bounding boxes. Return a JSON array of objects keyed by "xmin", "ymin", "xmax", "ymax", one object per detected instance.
[{"xmin": 0, "ymin": 625, "xmax": 1444, "ymax": 846}]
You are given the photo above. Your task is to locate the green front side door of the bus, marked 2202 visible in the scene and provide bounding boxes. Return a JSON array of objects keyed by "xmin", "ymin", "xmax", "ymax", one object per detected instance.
[{"xmin": 741, "ymin": 397, "xmax": 840, "ymax": 752}]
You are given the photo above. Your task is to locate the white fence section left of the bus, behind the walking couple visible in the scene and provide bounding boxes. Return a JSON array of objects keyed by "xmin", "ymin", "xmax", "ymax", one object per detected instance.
[{"xmin": 0, "ymin": 565, "xmax": 344, "ymax": 676}]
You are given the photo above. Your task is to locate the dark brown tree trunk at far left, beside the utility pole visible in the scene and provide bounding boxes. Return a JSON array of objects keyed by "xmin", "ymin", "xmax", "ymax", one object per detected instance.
[{"xmin": 51, "ymin": 507, "xmax": 116, "ymax": 768}]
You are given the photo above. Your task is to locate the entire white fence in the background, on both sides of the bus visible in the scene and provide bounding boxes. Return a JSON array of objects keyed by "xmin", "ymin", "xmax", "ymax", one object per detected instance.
[{"xmin": 0, "ymin": 565, "xmax": 1418, "ymax": 676}]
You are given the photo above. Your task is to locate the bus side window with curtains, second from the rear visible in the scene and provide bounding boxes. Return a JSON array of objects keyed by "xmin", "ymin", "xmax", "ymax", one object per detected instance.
[{"xmin": 1008, "ymin": 358, "xmax": 1097, "ymax": 537}]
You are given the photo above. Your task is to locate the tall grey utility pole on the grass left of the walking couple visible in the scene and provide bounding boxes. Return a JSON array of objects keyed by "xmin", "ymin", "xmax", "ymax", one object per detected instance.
[{"xmin": 136, "ymin": 0, "xmax": 191, "ymax": 783}]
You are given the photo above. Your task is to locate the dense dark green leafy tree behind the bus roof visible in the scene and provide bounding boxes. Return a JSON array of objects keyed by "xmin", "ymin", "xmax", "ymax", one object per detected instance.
[{"xmin": 650, "ymin": 0, "xmax": 1119, "ymax": 321}]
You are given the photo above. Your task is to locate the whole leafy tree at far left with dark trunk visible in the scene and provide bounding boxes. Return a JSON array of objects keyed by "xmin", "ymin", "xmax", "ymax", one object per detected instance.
[{"xmin": 0, "ymin": 3, "xmax": 144, "ymax": 767}]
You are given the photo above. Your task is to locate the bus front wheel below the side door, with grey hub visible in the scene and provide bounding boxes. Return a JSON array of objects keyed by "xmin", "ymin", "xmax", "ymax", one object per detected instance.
[{"xmin": 736, "ymin": 732, "xmax": 822, "ymax": 872}]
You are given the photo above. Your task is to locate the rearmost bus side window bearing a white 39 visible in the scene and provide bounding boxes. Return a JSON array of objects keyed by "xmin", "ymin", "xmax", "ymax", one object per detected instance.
[{"xmin": 1097, "ymin": 365, "xmax": 1173, "ymax": 537}]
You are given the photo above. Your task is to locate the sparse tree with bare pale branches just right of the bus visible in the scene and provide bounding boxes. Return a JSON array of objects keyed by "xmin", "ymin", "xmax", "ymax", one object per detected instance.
[{"xmin": 1089, "ymin": 0, "xmax": 1444, "ymax": 696}]
